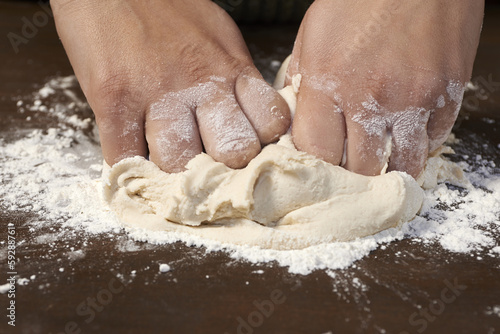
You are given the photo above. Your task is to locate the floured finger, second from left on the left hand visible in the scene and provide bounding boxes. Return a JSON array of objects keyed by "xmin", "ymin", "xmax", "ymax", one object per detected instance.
[{"xmin": 146, "ymin": 98, "xmax": 202, "ymax": 173}]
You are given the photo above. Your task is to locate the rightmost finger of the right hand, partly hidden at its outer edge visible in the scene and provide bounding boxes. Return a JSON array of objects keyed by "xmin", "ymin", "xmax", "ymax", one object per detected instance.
[{"xmin": 427, "ymin": 81, "xmax": 465, "ymax": 152}]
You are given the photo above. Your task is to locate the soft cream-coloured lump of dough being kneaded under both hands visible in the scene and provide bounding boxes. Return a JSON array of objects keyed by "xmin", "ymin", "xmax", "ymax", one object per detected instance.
[{"xmin": 104, "ymin": 78, "xmax": 430, "ymax": 249}]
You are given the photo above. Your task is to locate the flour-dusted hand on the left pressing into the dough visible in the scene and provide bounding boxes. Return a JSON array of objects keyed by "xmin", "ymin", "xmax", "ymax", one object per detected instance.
[{"xmin": 51, "ymin": 0, "xmax": 291, "ymax": 172}]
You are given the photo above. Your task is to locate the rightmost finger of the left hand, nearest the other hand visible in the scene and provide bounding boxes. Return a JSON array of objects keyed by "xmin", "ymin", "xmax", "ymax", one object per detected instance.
[{"xmin": 235, "ymin": 69, "xmax": 291, "ymax": 145}]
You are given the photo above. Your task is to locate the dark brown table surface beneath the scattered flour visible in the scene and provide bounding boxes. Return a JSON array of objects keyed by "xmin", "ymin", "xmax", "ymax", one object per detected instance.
[{"xmin": 0, "ymin": 1, "xmax": 500, "ymax": 334}]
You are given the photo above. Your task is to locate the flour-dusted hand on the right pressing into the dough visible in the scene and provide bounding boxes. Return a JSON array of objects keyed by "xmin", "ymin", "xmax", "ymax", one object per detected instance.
[{"xmin": 286, "ymin": 0, "xmax": 484, "ymax": 177}]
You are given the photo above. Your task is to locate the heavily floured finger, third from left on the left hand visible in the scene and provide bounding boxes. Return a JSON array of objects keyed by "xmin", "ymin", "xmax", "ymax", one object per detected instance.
[{"xmin": 196, "ymin": 92, "xmax": 260, "ymax": 168}]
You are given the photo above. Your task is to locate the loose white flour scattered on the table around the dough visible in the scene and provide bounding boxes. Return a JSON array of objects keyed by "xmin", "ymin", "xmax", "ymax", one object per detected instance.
[{"xmin": 0, "ymin": 77, "xmax": 500, "ymax": 274}]
